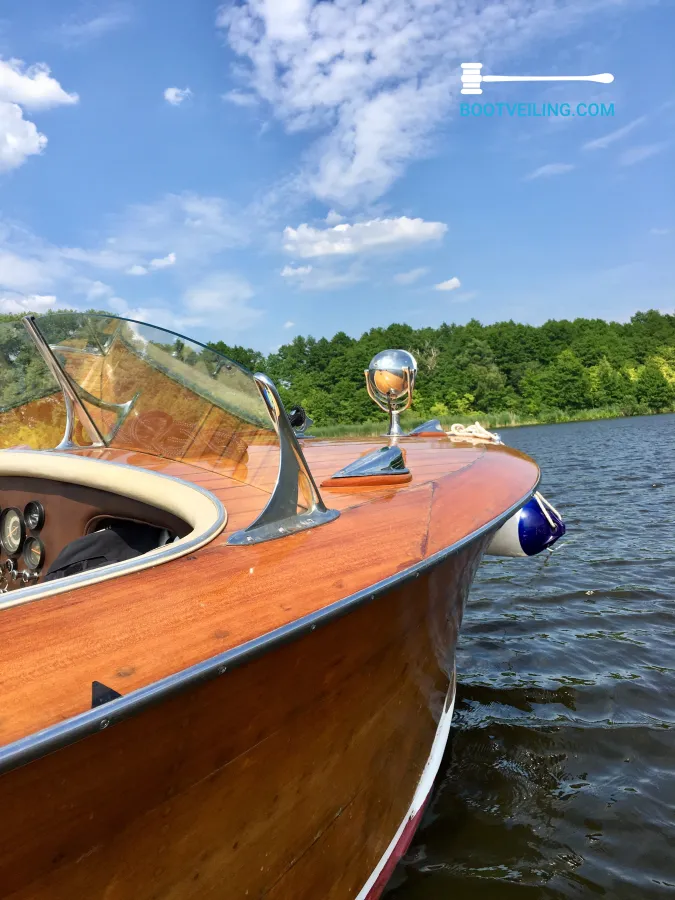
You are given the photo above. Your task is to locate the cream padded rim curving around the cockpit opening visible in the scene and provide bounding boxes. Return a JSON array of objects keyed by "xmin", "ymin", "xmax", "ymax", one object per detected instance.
[{"xmin": 0, "ymin": 450, "xmax": 227, "ymax": 609}]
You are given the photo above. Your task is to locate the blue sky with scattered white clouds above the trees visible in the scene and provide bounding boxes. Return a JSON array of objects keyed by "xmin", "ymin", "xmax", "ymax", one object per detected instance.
[{"xmin": 0, "ymin": 0, "xmax": 675, "ymax": 352}]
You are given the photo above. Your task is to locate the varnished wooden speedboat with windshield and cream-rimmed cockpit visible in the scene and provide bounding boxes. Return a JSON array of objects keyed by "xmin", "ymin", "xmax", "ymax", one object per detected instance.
[{"xmin": 0, "ymin": 314, "xmax": 560, "ymax": 900}]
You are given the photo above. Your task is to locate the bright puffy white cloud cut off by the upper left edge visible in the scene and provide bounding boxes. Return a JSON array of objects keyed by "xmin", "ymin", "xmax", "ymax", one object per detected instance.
[{"xmin": 0, "ymin": 59, "xmax": 78, "ymax": 172}]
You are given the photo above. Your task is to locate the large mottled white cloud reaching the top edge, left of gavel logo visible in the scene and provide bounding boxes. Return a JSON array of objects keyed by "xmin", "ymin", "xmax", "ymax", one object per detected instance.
[{"xmin": 217, "ymin": 0, "xmax": 640, "ymax": 207}]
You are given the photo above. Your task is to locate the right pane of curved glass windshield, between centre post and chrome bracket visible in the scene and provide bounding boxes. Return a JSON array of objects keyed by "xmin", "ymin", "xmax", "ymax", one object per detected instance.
[{"xmin": 35, "ymin": 313, "xmax": 276, "ymax": 463}]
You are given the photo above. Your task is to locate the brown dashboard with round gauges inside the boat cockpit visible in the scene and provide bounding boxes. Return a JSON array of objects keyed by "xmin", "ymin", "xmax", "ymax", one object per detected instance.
[{"xmin": 0, "ymin": 476, "xmax": 190, "ymax": 593}]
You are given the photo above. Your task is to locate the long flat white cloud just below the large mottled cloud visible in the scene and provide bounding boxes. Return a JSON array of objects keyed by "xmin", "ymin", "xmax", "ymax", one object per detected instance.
[{"xmin": 283, "ymin": 216, "xmax": 448, "ymax": 259}]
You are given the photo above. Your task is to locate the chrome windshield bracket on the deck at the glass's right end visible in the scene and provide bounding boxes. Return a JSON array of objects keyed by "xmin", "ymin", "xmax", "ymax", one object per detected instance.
[{"xmin": 227, "ymin": 374, "xmax": 340, "ymax": 546}]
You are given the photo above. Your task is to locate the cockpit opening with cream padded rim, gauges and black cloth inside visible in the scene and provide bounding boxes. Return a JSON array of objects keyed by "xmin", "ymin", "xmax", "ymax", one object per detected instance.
[{"xmin": 0, "ymin": 450, "xmax": 227, "ymax": 608}]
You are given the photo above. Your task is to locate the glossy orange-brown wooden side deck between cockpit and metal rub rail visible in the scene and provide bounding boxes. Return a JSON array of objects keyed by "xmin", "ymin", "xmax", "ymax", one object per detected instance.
[{"xmin": 0, "ymin": 448, "xmax": 537, "ymax": 743}]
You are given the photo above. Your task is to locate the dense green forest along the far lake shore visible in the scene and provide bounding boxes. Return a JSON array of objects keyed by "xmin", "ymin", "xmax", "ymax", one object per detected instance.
[{"xmin": 0, "ymin": 310, "xmax": 675, "ymax": 433}]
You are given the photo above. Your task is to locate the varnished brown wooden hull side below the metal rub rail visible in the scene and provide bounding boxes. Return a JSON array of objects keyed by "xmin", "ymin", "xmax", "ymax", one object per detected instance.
[{"xmin": 0, "ymin": 534, "xmax": 489, "ymax": 900}]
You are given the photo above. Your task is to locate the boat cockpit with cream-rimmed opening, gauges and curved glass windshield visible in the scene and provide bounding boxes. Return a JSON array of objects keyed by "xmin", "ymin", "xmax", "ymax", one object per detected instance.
[{"xmin": 0, "ymin": 313, "xmax": 338, "ymax": 608}]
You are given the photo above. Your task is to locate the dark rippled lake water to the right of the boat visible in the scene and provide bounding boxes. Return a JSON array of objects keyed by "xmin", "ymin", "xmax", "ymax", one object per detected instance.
[{"xmin": 386, "ymin": 415, "xmax": 675, "ymax": 900}]
